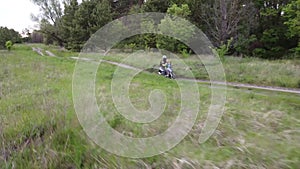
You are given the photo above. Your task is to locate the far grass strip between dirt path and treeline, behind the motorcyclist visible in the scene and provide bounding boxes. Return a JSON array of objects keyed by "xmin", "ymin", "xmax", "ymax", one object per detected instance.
[{"xmin": 96, "ymin": 52, "xmax": 300, "ymax": 88}]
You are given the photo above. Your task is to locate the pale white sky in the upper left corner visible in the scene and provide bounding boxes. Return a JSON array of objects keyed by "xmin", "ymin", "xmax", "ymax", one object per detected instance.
[{"xmin": 0, "ymin": 0, "xmax": 39, "ymax": 33}]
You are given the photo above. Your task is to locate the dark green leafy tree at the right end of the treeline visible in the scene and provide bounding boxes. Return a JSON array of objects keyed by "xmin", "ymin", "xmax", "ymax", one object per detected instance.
[{"xmin": 250, "ymin": 0, "xmax": 297, "ymax": 59}]
